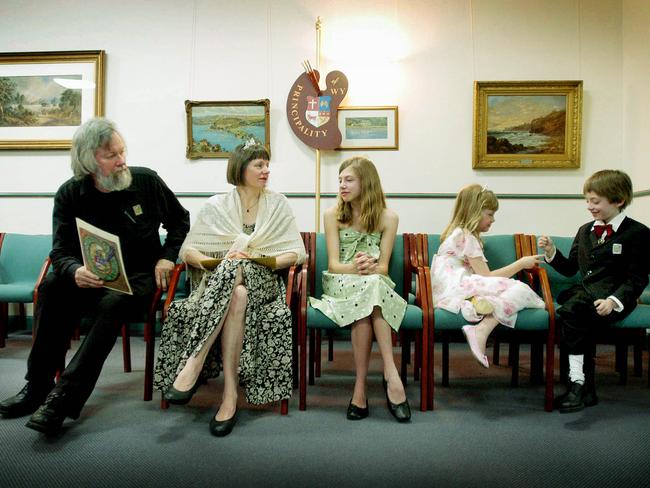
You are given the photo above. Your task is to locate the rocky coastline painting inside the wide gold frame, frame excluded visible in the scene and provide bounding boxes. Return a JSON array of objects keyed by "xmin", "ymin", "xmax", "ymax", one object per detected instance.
[{"xmin": 486, "ymin": 95, "xmax": 567, "ymax": 154}]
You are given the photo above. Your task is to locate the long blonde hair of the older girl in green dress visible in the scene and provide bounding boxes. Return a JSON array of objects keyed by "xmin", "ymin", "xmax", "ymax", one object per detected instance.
[{"xmin": 336, "ymin": 156, "xmax": 386, "ymax": 232}]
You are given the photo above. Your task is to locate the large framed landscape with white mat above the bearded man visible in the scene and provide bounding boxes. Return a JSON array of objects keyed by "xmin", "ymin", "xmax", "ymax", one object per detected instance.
[{"xmin": 0, "ymin": 51, "xmax": 105, "ymax": 149}]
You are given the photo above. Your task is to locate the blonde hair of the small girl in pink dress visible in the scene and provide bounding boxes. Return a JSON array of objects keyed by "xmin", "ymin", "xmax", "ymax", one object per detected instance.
[{"xmin": 440, "ymin": 184, "xmax": 499, "ymax": 242}]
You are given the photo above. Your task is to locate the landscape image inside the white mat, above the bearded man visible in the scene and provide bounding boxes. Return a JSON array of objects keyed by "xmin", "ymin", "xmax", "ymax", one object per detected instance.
[{"xmin": 0, "ymin": 75, "xmax": 82, "ymax": 127}]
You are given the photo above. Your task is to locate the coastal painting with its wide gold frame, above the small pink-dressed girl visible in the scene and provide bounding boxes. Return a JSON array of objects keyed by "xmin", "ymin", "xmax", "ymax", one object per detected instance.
[{"xmin": 472, "ymin": 81, "xmax": 582, "ymax": 169}]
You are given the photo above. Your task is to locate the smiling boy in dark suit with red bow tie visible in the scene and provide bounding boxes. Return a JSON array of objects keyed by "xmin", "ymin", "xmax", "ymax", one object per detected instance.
[{"xmin": 538, "ymin": 170, "xmax": 650, "ymax": 413}]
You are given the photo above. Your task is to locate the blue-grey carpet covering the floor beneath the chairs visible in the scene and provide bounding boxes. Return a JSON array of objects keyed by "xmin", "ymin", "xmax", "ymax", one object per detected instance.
[{"xmin": 0, "ymin": 333, "xmax": 650, "ymax": 488}]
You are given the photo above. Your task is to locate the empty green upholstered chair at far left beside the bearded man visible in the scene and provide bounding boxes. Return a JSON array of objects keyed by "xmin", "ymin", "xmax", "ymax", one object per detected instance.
[{"xmin": 0, "ymin": 233, "xmax": 52, "ymax": 347}]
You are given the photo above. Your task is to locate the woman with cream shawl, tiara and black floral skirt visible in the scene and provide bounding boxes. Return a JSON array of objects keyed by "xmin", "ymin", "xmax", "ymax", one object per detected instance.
[{"xmin": 154, "ymin": 141, "xmax": 305, "ymax": 437}]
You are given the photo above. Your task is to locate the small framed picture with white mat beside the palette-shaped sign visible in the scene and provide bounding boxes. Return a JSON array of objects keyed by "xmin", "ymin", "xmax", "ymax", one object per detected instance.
[{"xmin": 337, "ymin": 106, "xmax": 399, "ymax": 150}]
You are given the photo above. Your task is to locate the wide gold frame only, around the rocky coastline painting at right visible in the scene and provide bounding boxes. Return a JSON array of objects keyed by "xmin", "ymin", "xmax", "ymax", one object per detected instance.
[{"xmin": 472, "ymin": 81, "xmax": 582, "ymax": 169}]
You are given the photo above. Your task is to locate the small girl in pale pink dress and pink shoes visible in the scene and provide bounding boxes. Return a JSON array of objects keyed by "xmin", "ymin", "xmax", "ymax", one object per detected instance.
[{"xmin": 431, "ymin": 184, "xmax": 544, "ymax": 368}]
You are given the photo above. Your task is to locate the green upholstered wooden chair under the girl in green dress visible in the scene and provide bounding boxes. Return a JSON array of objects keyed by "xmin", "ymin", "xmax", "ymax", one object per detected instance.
[{"xmin": 298, "ymin": 233, "xmax": 431, "ymax": 411}]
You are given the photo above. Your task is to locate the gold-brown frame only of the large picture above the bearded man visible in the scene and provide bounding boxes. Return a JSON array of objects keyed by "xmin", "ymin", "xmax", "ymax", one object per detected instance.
[{"xmin": 0, "ymin": 51, "xmax": 105, "ymax": 150}]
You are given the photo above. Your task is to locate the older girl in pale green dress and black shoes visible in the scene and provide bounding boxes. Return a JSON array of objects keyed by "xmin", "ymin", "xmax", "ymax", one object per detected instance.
[{"xmin": 311, "ymin": 157, "xmax": 411, "ymax": 422}]
